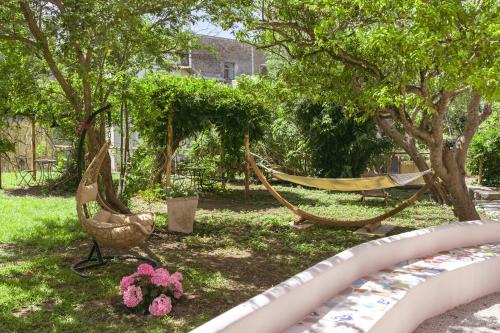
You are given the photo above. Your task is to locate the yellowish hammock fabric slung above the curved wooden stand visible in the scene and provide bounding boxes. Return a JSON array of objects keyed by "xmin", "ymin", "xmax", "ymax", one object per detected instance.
[{"xmin": 266, "ymin": 168, "xmax": 432, "ymax": 191}]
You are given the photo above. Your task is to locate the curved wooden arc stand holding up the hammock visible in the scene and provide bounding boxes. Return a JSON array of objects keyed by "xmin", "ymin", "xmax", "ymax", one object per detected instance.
[{"xmin": 245, "ymin": 136, "xmax": 437, "ymax": 227}]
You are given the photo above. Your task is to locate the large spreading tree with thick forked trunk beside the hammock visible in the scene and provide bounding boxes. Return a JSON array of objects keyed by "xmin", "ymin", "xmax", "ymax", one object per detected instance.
[{"xmin": 228, "ymin": 0, "xmax": 500, "ymax": 220}]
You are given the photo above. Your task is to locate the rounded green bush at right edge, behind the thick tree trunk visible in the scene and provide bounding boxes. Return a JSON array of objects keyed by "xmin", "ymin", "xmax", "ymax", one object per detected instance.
[{"xmin": 468, "ymin": 110, "xmax": 500, "ymax": 186}]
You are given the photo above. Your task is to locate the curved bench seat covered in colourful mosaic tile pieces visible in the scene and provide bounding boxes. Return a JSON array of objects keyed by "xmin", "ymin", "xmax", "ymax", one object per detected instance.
[{"xmin": 285, "ymin": 243, "xmax": 500, "ymax": 333}]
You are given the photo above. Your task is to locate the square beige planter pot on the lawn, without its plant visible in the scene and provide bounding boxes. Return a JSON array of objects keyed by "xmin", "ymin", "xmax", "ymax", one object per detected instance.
[{"xmin": 167, "ymin": 196, "xmax": 198, "ymax": 234}]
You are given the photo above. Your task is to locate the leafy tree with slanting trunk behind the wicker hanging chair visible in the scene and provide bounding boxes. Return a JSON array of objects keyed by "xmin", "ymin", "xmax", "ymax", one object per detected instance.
[{"xmin": 0, "ymin": 0, "xmax": 198, "ymax": 211}]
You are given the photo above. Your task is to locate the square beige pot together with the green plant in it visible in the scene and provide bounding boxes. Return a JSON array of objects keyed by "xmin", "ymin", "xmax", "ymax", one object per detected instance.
[{"xmin": 164, "ymin": 181, "xmax": 198, "ymax": 234}]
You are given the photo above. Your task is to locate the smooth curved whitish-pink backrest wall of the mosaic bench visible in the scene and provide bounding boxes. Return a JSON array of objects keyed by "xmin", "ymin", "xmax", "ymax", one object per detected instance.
[{"xmin": 192, "ymin": 221, "xmax": 500, "ymax": 333}]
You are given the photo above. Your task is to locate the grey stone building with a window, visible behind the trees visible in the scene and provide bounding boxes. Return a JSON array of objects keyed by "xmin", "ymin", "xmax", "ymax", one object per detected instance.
[{"xmin": 180, "ymin": 35, "xmax": 266, "ymax": 83}]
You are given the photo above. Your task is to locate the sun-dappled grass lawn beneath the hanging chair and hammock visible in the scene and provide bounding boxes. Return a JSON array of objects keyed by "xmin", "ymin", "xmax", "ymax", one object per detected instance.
[{"xmin": 0, "ymin": 186, "xmax": 455, "ymax": 332}]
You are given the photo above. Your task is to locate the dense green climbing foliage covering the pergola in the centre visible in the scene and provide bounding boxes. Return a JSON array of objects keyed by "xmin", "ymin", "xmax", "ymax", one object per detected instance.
[{"xmin": 131, "ymin": 74, "xmax": 266, "ymax": 191}]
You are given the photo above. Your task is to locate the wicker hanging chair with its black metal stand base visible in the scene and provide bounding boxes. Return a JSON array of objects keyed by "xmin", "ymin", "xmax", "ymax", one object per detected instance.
[{"xmin": 71, "ymin": 105, "xmax": 158, "ymax": 277}]
